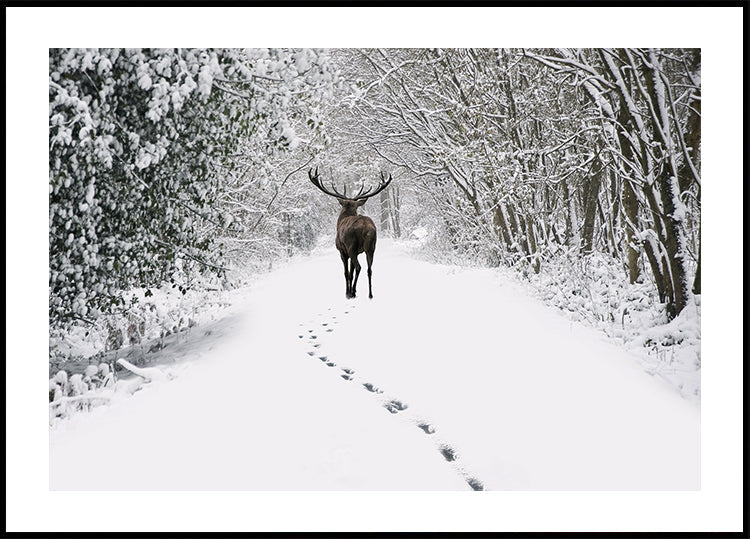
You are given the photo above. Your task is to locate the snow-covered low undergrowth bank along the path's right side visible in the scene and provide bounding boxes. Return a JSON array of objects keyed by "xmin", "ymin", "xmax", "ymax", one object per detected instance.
[{"xmin": 512, "ymin": 248, "xmax": 701, "ymax": 403}]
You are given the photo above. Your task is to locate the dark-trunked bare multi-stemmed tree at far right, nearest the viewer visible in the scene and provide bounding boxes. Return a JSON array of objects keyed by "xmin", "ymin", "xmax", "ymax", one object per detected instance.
[{"xmin": 531, "ymin": 49, "xmax": 701, "ymax": 317}]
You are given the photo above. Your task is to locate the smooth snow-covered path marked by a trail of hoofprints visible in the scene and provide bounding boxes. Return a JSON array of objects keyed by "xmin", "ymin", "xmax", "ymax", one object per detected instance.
[{"xmin": 50, "ymin": 240, "xmax": 700, "ymax": 490}]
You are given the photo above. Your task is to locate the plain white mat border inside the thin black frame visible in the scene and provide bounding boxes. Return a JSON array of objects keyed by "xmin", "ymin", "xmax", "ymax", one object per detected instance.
[{"xmin": 6, "ymin": 7, "xmax": 743, "ymax": 532}]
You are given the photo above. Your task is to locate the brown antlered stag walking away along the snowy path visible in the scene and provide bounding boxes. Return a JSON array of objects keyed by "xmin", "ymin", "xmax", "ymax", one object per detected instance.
[{"xmin": 307, "ymin": 167, "xmax": 393, "ymax": 299}]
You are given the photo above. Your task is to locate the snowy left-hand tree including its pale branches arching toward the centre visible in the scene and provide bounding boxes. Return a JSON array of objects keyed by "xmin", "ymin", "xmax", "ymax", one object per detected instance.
[{"xmin": 49, "ymin": 49, "xmax": 337, "ymax": 330}]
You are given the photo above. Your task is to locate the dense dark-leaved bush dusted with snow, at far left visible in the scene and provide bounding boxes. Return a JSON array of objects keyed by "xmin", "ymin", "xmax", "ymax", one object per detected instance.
[{"xmin": 49, "ymin": 49, "xmax": 229, "ymax": 323}]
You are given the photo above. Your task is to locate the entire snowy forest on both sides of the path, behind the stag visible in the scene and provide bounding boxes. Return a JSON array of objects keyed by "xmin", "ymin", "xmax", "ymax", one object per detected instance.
[{"xmin": 49, "ymin": 48, "xmax": 701, "ymax": 372}]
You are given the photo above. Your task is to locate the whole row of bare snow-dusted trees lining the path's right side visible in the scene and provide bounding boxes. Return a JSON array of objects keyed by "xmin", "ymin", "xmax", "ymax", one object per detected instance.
[{"xmin": 334, "ymin": 49, "xmax": 700, "ymax": 317}]
